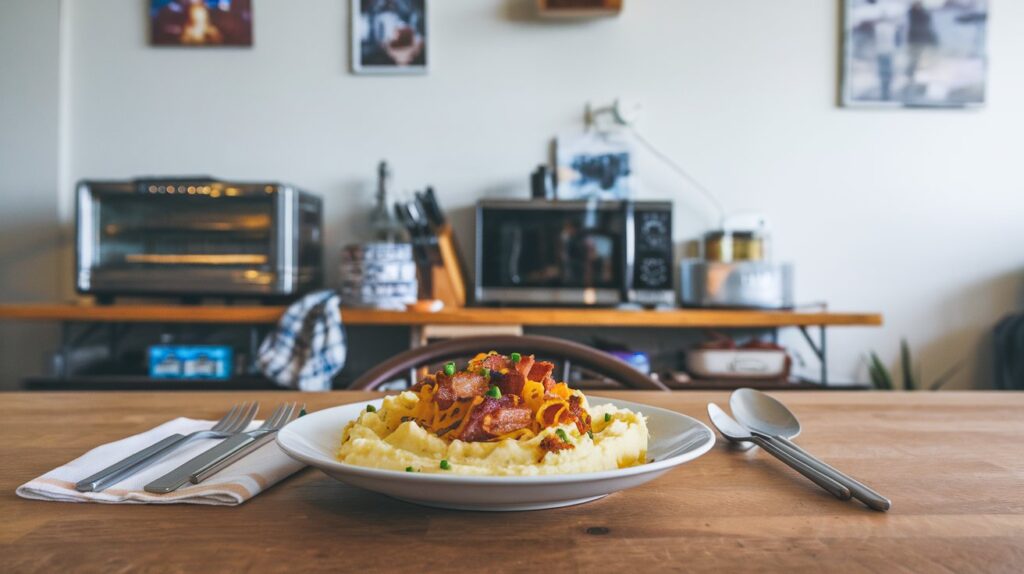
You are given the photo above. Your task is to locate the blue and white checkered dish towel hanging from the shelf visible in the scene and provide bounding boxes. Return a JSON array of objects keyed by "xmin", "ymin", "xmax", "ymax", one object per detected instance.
[{"xmin": 257, "ymin": 290, "xmax": 348, "ymax": 391}]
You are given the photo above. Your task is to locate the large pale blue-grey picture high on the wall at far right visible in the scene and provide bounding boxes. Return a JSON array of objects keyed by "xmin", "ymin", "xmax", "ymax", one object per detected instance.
[{"xmin": 842, "ymin": 0, "xmax": 988, "ymax": 107}]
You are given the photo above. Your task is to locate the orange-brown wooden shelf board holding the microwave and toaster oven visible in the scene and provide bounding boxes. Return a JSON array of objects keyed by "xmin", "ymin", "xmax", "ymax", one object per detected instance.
[{"xmin": 0, "ymin": 303, "xmax": 882, "ymax": 328}]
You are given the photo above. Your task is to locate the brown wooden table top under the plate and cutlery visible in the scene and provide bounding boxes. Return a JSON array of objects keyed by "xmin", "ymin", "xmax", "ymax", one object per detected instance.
[{"xmin": 0, "ymin": 391, "xmax": 1024, "ymax": 573}]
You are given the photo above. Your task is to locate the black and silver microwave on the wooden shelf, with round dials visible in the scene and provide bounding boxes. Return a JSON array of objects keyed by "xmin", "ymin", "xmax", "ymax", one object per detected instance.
[{"xmin": 475, "ymin": 200, "xmax": 674, "ymax": 306}]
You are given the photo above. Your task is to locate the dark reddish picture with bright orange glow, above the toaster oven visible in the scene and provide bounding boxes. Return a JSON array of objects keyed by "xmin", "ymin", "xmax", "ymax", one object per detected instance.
[{"xmin": 150, "ymin": 0, "xmax": 253, "ymax": 46}]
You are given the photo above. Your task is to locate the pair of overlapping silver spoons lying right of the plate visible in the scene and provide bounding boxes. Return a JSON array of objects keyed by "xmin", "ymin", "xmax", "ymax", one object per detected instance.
[{"xmin": 708, "ymin": 389, "xmax": 892, "ymax": 512}]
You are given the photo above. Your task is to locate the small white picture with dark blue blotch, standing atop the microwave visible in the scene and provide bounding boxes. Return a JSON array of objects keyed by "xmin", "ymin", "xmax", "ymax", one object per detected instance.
[{"xmin": 555, "ymin": 131, "xmax": 633, "ymax": 200}]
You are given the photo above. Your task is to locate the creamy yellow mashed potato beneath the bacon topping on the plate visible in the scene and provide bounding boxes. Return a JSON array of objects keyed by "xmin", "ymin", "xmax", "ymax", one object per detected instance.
[{"xmin": 338, "ymin": 391, "xmax": 648, "ymax": 476}]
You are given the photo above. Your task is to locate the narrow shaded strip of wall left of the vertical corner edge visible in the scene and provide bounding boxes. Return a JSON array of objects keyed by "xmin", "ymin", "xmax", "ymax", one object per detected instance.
[{"xmin": 0, "ymin": 0, "xmax": 61, "ymax": 389}]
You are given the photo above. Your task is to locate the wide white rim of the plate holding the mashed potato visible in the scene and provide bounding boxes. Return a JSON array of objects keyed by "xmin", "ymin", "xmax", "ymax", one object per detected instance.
[{"xmin": 274, "ymin": 395, "xmax": 717, "ymax": 486}]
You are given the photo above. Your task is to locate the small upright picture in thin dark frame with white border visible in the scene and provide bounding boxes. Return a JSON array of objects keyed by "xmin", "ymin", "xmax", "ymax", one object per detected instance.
[{"xmin": 350, "ymin": 0, "xmax": 428, "ymax": 74}]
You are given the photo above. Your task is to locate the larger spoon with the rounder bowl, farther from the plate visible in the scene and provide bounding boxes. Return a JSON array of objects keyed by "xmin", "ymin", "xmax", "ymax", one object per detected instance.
[{"xmin": 729, "ymin": 389, "xmax": 892, "ymax": 512}]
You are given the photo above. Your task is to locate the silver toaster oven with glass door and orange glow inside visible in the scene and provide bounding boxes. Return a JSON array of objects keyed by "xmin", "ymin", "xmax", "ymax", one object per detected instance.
[{"xmin": 76, "ymin": 177, "xmax": 323, "ymax": 300}]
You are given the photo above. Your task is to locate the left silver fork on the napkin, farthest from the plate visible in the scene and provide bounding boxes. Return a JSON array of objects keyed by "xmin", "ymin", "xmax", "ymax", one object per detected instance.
[{"xmin": 75, "ymin": 401, "xmax": 259, "ymax": 492}]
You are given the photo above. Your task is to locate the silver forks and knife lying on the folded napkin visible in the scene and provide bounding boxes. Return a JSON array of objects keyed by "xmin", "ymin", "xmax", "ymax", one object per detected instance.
[{"xmin": 75, "ymin": 402, "xmax": 305, "ymax": 494}]
